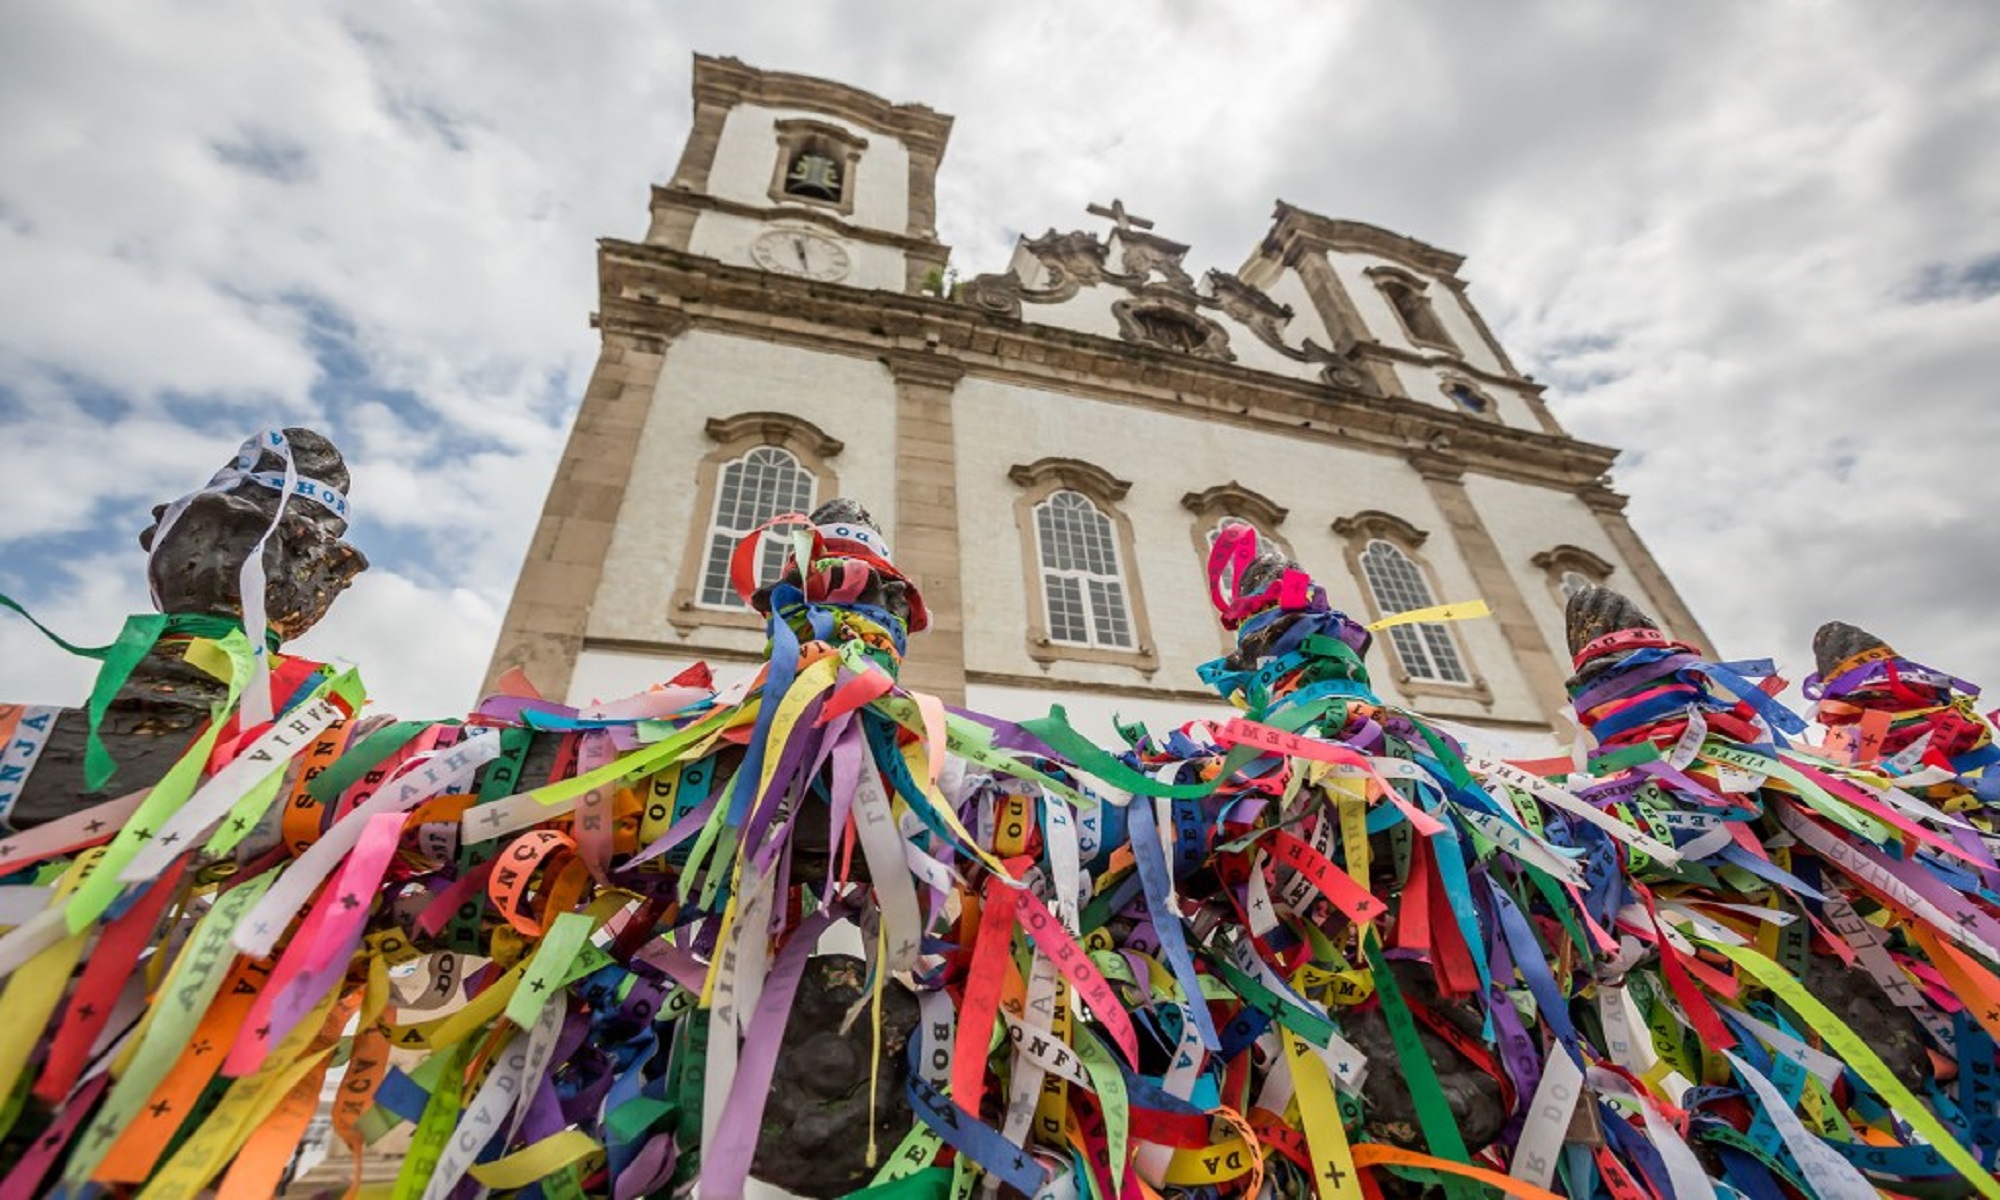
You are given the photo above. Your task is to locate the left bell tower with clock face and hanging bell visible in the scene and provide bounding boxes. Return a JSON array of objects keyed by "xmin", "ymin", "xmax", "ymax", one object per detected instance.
[{"xmin": 646, "ymin": 54, "xmax": 952, "ymax": 292}]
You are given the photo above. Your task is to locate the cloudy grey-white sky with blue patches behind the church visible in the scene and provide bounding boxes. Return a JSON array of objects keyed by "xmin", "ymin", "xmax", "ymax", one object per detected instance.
[{"xmin": 0, "ymin": 0, "xmax": 2000, "ymax": 712}]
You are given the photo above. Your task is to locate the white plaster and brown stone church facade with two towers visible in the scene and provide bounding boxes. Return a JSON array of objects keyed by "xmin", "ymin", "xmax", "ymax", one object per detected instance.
[{"xmin": 490, "ymin": 56, "xmax": 1708, "ymax": 742}]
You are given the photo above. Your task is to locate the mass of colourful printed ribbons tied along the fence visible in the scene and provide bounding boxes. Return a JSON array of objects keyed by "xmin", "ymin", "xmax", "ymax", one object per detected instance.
[{"xmin": 0, "ymin": 510, "xmax": 2000, "ymax": 1200}]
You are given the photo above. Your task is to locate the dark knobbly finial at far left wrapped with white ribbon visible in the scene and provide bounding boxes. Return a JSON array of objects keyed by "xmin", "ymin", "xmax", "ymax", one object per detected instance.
[{"xmin": 138, "ymin": 428, "xmax": 368, "ymax": 640}]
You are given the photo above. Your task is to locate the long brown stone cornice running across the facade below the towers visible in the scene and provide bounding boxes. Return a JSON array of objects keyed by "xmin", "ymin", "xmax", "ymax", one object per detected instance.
[{"xmin": 598, "ymin": 238, "xmax": 1618, "ymax": 492}]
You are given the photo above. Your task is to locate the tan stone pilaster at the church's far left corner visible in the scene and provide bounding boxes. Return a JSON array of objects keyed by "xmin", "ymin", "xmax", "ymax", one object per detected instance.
[{"xmin": 482, "ymin": 318, "xmax": 686, "ymax": 700}]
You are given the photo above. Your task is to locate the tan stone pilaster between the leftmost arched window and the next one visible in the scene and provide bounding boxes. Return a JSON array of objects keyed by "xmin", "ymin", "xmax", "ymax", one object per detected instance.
[{"xmin": 882, "ymin": 352, "xmax": 966, "ymax": 704}]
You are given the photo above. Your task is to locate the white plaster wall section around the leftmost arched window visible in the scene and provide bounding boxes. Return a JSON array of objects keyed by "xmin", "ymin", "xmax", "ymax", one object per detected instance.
[{"xmin": 584, "ymin": 328, "xmax": 896, "ymax": 656}]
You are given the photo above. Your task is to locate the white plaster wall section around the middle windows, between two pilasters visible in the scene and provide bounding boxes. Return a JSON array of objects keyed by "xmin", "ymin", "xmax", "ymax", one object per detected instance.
[{"xmin": 954, "ymin": 378, "xmax": 1540, "ymax": 722}]
